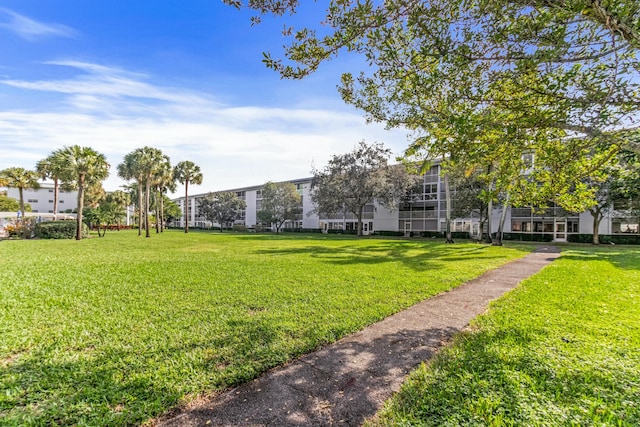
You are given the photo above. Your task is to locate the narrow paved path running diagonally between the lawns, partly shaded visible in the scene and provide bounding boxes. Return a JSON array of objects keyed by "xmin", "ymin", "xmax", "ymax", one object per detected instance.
[{"xmin": 159, "ymin": 246, "xmax": 560, "ymax": 427}]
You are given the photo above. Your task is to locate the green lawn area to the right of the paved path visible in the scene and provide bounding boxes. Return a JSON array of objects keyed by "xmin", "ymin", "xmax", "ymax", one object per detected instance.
[{"xmin": 370, "ymin": 246, "xmax": 640, "ymax": 426}]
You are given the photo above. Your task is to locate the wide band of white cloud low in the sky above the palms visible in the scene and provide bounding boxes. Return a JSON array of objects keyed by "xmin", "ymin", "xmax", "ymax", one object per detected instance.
[{"xmin": 0, "ymin": 61, "xmax": 406, "ymax": 193}]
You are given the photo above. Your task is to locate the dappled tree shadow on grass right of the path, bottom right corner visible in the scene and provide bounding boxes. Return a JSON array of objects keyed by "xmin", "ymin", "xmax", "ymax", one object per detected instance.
[{"xmin": 382, "ymin": 327, "xmax": 640, "ymax": 426}]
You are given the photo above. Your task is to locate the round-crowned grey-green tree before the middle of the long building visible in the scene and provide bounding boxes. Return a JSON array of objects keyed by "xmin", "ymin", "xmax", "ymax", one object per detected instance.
[{"xmin": 311, "ymin": 141, "xmax": 418, "ymax": 236}]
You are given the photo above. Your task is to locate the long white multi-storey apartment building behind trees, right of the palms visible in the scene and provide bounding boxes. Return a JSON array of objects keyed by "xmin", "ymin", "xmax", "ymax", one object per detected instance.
[{"xmin": 172, "ymin": 164, "xmax": 639, "ymax": 242}]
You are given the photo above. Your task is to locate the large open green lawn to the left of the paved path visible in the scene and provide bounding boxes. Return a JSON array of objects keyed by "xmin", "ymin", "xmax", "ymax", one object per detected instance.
[{"xmin": 0, "ymin": 232, "xmax": 530, "ymax": 425}]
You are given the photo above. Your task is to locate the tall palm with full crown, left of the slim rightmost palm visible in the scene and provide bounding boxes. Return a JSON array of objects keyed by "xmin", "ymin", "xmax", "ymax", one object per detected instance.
[{"xmin": 118, "ymin": 147, "xmax": 168, "ymax": 237}]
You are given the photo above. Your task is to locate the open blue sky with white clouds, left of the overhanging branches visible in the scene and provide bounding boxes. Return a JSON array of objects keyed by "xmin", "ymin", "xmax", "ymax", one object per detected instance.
[{"xmin": 0, "ymin": 0, "xmax": 407, "ymax": 193}]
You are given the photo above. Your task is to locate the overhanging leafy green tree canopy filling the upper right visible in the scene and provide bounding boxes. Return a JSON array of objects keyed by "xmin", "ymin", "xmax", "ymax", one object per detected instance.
[{"xmin": 225, "ymin": 0, "xmax": 640, "ymax": 214}]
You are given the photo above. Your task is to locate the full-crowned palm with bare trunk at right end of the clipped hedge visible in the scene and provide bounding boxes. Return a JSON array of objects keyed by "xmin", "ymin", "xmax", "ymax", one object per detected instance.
[{"xmin": 52, "ymin": 145, "xmax": 109, "ymax": 240}]
